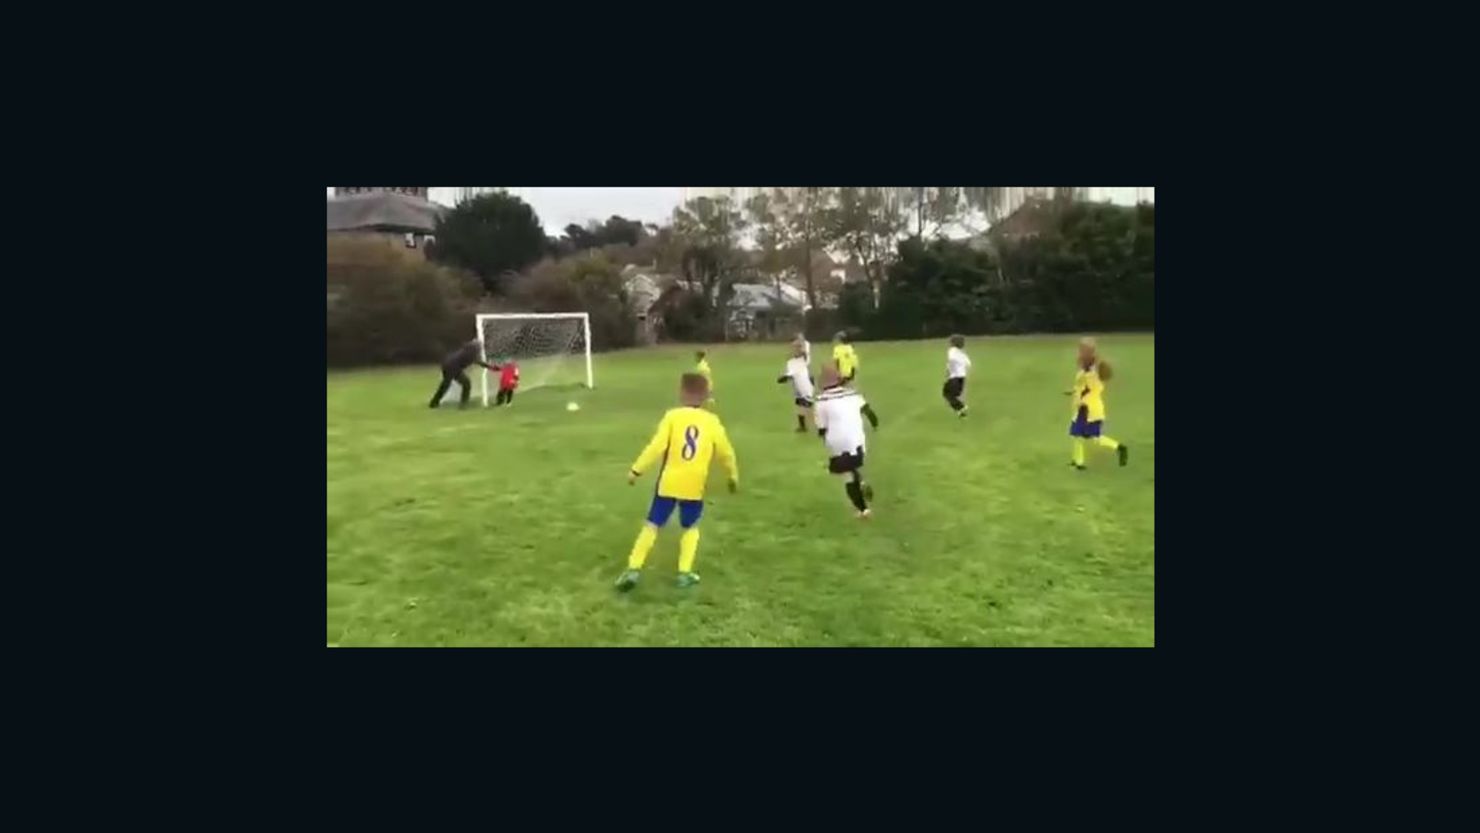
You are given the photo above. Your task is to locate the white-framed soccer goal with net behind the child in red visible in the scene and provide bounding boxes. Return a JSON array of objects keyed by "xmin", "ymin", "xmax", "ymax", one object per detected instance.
[{"xmin": 478, "ymin": 312, "xmax": 596, "ymax": 407}]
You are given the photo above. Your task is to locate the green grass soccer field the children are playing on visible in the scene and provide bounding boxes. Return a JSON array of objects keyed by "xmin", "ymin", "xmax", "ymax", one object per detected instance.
[{"xmin": 327, "ymin": 336, "xmax": 1156, "ymax": 647}]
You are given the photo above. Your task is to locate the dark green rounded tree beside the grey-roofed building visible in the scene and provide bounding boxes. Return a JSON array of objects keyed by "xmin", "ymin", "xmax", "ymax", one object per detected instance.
[{"xmin": 428, "ymin": 191, "xmax": 546, "ymax": 293}]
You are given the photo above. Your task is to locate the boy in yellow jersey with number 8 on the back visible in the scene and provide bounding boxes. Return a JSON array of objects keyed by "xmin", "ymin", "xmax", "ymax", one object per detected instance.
[{"xmin": 617, "ymin": 373, "xmax": 740, "ymax": 590}]
